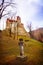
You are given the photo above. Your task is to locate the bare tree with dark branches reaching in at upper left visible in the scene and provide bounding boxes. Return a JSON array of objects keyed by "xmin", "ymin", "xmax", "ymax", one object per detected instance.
[{"xmin": 0, "ymin": 0, "xmax": 16, "ymax": 19}]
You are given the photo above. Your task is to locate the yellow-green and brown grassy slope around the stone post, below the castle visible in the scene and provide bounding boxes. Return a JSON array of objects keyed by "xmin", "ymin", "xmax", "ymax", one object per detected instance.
[{"xmin": 0, "ymin": 31, "xmax": 43, "ymax": 65}]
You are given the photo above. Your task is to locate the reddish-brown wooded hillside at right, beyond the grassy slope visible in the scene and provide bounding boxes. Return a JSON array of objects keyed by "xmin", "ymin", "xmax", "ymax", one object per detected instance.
[{"xmin": 32, "ymin": 28, "xmax": 43, "ymax": 42}]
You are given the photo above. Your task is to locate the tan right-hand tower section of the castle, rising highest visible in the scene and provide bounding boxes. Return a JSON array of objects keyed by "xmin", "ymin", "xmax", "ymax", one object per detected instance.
[{"xmin": 17, "ymin": 16, "xmax": 27, "ymax": 35}]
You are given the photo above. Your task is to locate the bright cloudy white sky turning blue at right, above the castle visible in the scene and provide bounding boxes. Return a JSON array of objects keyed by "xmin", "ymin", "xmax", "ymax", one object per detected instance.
[{"xmin": 0, "ymin": 0, "xmax": 43, "ymax": 31}]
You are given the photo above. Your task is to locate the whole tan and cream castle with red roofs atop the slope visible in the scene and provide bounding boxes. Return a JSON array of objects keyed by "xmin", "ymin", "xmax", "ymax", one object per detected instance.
[{"xmin": 6, "ymin": 16, "xmax": 27, "ymax": 35}]
